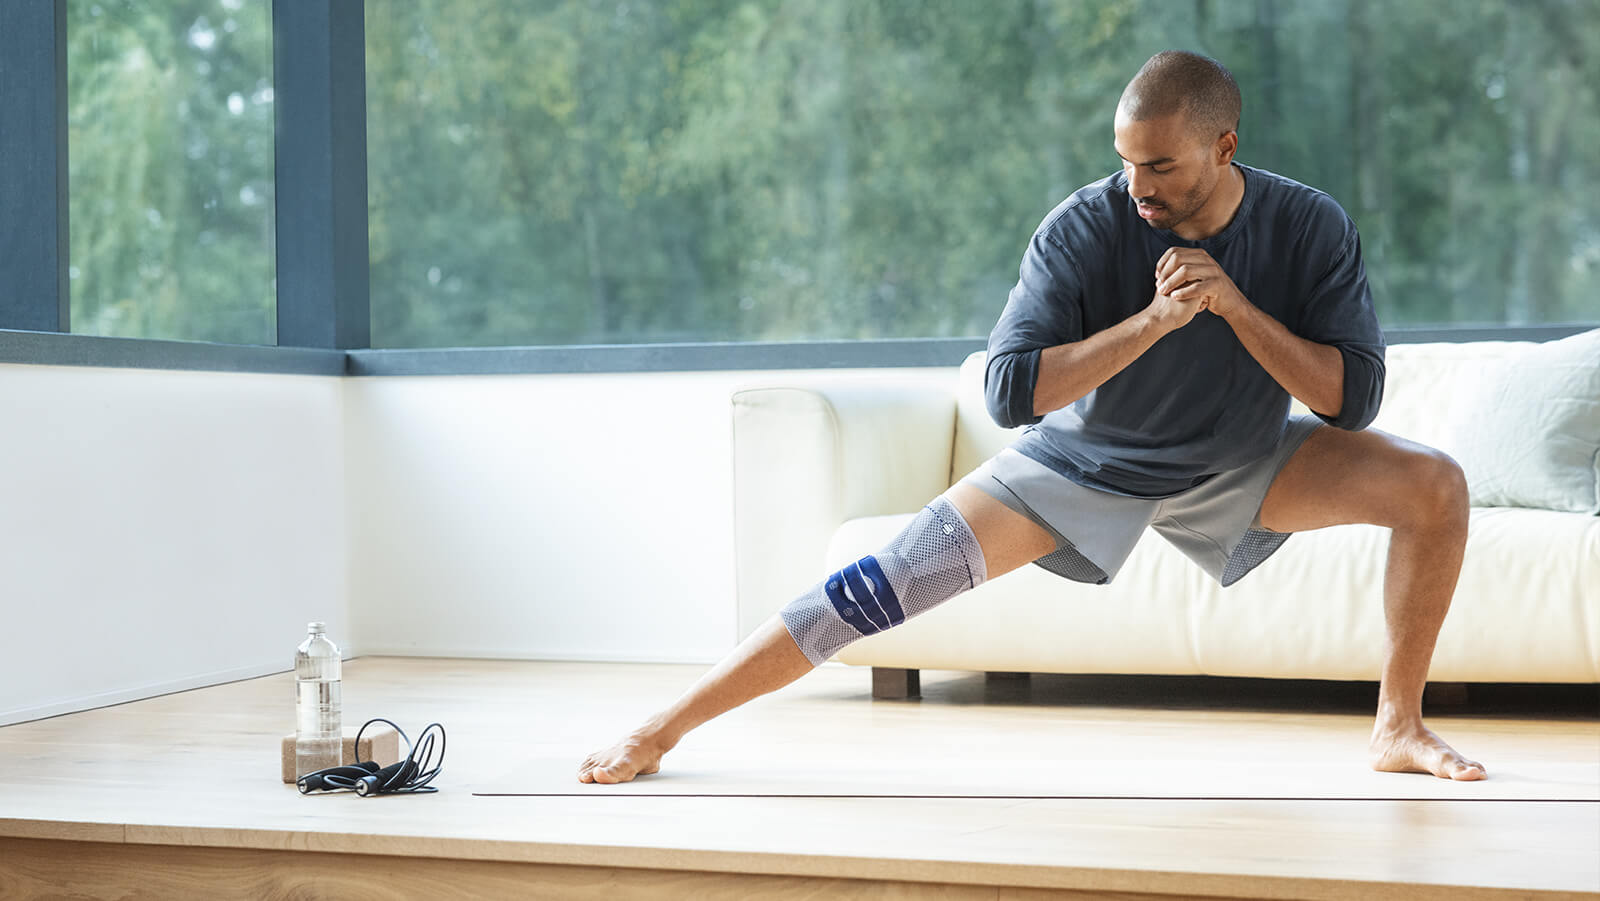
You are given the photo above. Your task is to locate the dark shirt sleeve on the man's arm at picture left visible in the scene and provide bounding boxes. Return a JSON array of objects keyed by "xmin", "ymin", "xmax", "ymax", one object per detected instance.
[{"xmin": 984, "ymin": 232, "xmax": 1083, "ymax": 429}]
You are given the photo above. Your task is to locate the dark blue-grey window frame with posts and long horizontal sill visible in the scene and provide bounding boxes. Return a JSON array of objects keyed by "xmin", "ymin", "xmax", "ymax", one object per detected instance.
[{"xmin": 0, "ymin": 0, "xmax": 1600, "ymax": 376}]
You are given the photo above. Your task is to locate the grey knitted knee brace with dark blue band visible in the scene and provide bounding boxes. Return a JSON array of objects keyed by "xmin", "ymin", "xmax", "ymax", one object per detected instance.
[{"xmin": 779, "ymin": 495, "xmax": 987, "ymax": 666}]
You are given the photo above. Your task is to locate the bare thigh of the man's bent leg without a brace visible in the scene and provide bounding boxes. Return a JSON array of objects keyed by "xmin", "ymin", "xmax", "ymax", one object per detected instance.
[{"xmin": 1261, "ymin": 426, "xmax": 1464, "ymax": 531}]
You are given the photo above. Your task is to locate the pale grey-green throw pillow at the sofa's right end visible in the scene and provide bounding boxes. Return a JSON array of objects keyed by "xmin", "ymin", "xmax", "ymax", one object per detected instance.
[{"xmin": 1445, "ymin": 328, "xmax": 1600, "ymax": 514}]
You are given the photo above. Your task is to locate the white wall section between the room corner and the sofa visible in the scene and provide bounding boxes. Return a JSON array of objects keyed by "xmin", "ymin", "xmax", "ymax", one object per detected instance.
[{"xmin": 346, "ymin": 370, "xmax": 950, "ymax": 663}]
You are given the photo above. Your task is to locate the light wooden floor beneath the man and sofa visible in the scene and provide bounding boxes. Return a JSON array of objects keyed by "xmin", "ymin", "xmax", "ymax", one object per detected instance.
[{"xmin": 0, "ymin": 658, "xmax": 1600, "ymax": 899}]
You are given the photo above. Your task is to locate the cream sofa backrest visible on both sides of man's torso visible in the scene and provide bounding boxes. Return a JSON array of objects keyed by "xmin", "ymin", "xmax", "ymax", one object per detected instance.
[{"xmin": 950, "ymin": 341, "xmax": 1530, "ymax": 485}]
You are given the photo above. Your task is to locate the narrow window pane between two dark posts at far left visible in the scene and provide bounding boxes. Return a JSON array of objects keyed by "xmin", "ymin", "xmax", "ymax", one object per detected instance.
[{"xmin": 67, "ymin": 0, "xmax": 277, "ymax": 344}]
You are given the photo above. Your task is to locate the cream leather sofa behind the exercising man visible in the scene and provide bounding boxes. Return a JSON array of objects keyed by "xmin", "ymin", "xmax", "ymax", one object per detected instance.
[{"xmin": 733, "ymin": 331, "xmax": 1600, "ymax": 696}]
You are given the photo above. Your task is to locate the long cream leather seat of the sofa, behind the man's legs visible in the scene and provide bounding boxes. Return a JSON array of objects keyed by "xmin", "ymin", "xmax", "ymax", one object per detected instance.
[{"xmin": 826, "ymin": 507, "xmax": 1600, "ymax": 682}]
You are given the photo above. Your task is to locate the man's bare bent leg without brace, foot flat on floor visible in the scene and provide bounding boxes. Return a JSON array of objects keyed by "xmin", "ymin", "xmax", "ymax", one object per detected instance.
[{"xmin": 1261, "ymin": 427, "xmax": 1488, "ymax": 779}]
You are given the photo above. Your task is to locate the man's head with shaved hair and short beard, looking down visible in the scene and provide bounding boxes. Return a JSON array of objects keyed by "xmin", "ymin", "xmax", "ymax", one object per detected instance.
[{"xmin": 1115, "ymin": 50, "xmax": 1240, "ymax": 236}]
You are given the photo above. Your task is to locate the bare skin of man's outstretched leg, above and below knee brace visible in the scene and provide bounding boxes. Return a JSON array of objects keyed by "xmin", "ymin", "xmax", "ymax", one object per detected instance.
[{"xmin": 578, "ymin": 483, "xmax": 1056, "ymax": 783}]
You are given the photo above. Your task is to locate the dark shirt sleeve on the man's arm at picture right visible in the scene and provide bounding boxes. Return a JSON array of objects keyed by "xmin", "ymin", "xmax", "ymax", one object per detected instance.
[{"xmin": 1299, "ymin": 210, "xmax": 1386, "ymax": 432}]
